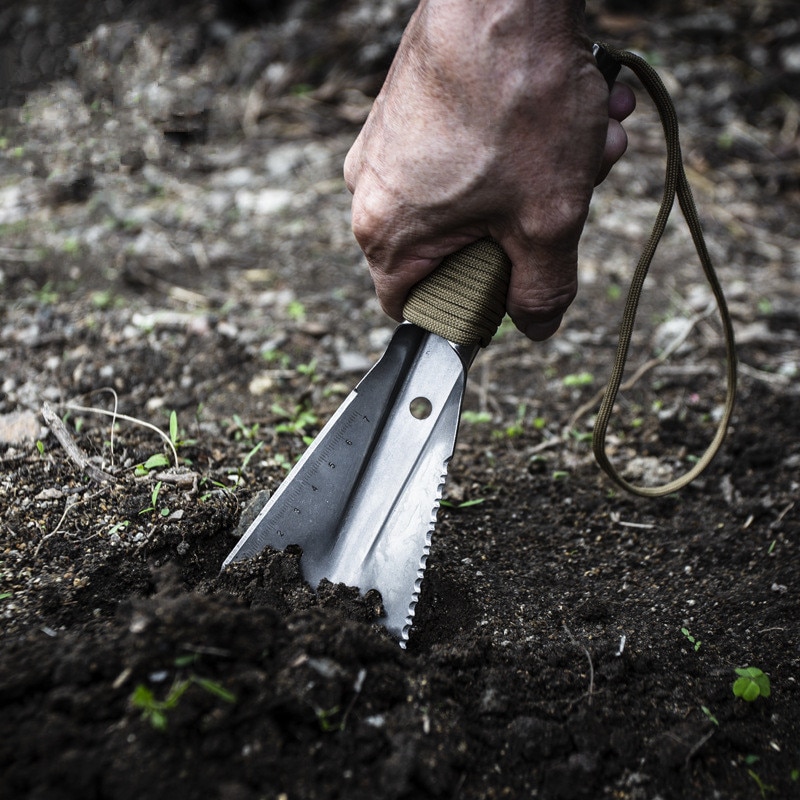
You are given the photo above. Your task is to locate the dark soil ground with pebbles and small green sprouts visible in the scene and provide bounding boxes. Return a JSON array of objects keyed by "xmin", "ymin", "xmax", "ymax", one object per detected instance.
[{"xmin": 0, "ymin": 0, "xmax": 800, "ymax": 800}]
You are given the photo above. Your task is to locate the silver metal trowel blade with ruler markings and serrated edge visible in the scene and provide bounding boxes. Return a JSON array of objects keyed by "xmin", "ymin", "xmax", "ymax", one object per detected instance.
[{"xmin": 223, "ymin": 324, "xmax": 478, "ymax": 642}]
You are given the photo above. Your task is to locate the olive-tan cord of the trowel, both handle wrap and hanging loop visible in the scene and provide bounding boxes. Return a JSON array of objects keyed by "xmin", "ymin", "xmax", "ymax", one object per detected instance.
[{"xmin": 404, "ymin": 45, "xmax": 736, "ymax": 497}]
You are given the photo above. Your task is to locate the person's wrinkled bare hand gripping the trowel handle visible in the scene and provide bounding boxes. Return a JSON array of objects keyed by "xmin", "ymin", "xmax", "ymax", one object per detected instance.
[{"xmin": 345, "ymin": 0, "xmax": 634, "ymax": 340}]
